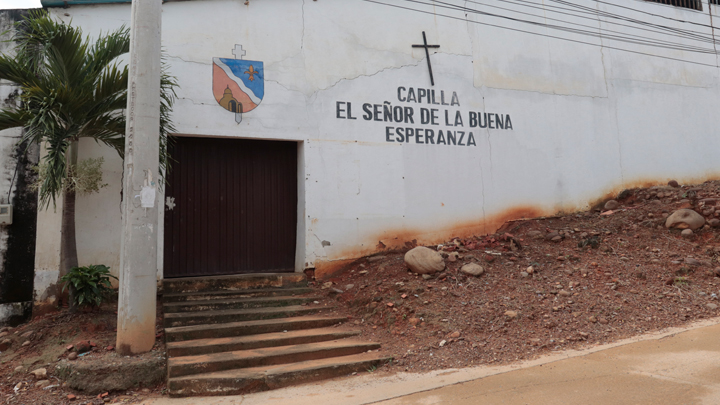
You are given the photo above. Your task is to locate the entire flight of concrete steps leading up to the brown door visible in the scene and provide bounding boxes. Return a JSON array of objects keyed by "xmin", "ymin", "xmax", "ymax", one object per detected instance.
[{"xmin": 163, "ymin": 273, "xmax": 390, "ymax": 397}]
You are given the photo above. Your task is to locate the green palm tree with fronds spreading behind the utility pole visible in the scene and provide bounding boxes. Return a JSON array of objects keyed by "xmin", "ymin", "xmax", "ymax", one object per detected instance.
[{"xmin": 0, "ymin": 10, "xmax": 177, "ymax": 296}]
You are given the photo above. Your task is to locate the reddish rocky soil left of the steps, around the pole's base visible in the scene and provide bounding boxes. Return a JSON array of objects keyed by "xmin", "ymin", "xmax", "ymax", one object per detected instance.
[{"xmin": 0, "ymin": 304, "xmax": 165, "ymax": 405}]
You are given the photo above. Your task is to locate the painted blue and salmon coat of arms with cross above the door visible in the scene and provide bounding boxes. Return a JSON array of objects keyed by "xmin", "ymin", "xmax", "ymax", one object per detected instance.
[{"xmin": 213, "ymin": 45, "xmax": 265, "ymax": 124}]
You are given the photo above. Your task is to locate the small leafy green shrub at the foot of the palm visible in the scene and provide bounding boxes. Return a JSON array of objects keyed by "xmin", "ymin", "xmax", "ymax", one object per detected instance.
[{"xmin": 60, "ymin": 264, "xmax": 117, "ymax": 307}]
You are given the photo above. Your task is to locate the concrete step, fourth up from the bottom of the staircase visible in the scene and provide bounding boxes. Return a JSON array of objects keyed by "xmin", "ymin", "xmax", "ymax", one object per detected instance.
[{"xmin": 165, "ymin": 315, "xmax": 347, "ymax": 342}]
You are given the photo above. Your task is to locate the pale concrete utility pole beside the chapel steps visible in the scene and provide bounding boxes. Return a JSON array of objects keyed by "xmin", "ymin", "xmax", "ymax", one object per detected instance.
[{"xmin": 116, "ymin": 0, "xmax": 162, "ymax": 355}]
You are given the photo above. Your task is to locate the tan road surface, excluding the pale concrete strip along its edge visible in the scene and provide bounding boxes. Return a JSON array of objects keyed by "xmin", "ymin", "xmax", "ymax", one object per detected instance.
[{"xmin": 379, "ymin": 325, "xmax": 720, "ymax": 405}]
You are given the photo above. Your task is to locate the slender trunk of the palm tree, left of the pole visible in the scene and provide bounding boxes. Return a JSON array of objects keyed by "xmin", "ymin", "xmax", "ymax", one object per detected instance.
[{"xmin": 60, "ymin": 141, "xmax": 78, "ymax": 312}]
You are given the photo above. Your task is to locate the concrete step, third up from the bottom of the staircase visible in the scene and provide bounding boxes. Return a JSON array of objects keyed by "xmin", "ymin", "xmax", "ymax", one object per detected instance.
[{"xmin": 167, "ymin": 328, "xmax": 360, "ymax": 357}]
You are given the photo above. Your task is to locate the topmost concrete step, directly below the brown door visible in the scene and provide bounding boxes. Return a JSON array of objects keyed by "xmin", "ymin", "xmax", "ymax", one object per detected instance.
[{"xmin": 163, "ymin": 273, "xmax": 307, "ymax": 294}]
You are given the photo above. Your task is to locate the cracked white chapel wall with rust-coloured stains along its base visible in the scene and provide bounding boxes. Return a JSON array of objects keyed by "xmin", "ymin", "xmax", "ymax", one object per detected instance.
[{"xmin": 53, "ymin": 0, "xmax": 720, "ymax": 274}]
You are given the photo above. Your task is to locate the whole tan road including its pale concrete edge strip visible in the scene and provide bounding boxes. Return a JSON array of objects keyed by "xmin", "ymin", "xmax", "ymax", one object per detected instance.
[{"xmin": 145, "ymin": 319, "xmax": 720, "ymax": 405}]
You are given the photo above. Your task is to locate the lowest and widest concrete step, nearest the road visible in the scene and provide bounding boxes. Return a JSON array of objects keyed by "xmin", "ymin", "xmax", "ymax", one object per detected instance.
[{"xmin": 168, "ymin": 352, "xmax": 391, "ymax": 397}]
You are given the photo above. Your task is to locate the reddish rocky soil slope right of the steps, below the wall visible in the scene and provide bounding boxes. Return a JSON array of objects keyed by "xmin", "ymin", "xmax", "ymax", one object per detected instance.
[{"xmin": 316, "ymin": 181, "xmax": 720, "ymax": 372}]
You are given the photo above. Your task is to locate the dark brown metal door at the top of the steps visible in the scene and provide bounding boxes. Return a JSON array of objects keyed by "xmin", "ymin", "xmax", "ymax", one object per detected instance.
[{"xmin": 163, "ymin": 137, "xmax": 298, "ymax": 278}]
